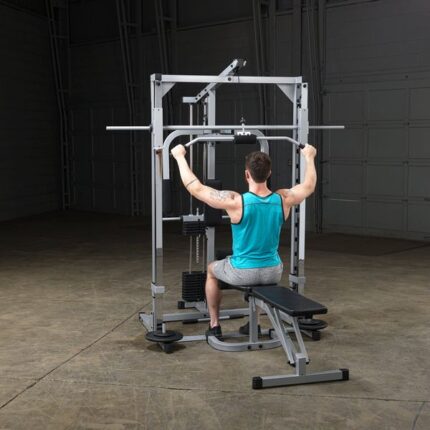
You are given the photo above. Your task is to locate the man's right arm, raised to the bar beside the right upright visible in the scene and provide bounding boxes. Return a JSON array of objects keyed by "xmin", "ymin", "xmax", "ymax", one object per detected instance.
[{"xmin": 277, "ymin": 145, "xmax": 317, "ymax": 207}]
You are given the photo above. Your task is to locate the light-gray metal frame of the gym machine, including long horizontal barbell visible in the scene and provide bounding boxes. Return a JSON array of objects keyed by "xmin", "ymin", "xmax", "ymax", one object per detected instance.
[{"xmin": 107, "ymin": 60, "xmax": 343, "ymax": 341}]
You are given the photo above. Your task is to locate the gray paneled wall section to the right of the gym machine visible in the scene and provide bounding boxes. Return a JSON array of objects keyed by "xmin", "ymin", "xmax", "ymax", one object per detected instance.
[{"xmin": 323, "ymin": 0, "xmax": 430, "ymax": 239}]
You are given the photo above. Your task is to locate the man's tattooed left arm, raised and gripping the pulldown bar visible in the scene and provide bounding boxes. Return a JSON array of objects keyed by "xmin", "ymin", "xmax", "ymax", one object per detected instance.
[{"xmin": 171, "ymin": 145, "xmax": 241, "ymax": 211}]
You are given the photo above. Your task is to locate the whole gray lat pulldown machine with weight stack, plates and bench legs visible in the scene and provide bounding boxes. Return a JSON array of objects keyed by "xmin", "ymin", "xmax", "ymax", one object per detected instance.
[{"xmin": 106, "ymin": 59, "xmax": 346, "ymax": 388}]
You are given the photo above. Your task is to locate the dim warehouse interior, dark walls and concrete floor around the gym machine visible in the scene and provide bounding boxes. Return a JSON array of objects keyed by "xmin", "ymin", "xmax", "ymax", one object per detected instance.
[{"xmin": 0, "ymin": 0, "xmax": 430, "ymax": 430}]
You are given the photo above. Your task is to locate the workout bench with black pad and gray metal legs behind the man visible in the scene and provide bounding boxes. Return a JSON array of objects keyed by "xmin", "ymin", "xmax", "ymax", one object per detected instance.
[{"xmin": 208, "ymin": 285, "xmax": 349, "ymax": 389}]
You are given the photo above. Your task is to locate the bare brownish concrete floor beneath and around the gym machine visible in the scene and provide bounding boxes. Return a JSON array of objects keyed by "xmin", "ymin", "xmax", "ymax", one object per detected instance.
[{"xmin": 0, "ymin": 214, "xmax": 430, "ymax": 430}]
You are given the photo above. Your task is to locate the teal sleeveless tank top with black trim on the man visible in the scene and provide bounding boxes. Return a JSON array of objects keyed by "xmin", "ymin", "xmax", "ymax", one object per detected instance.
[{"xmin": 230, "ymin": 192, "xmax": 284, "ymax": 269}]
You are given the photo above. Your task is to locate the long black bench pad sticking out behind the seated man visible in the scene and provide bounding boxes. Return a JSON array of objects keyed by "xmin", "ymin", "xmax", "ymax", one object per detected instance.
[{"xmin": 250, "ymin": 286, "xmax": 327, "ymax": 317}]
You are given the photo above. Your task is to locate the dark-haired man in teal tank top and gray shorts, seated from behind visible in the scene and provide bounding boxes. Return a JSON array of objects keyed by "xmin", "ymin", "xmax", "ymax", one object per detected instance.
[{"xmin": 172, "ymin": 145, "xmax": 317, "ymax": 338}]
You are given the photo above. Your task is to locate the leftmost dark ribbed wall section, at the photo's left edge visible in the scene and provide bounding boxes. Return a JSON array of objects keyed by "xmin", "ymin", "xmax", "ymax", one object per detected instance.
[{"xmin": 0, "ymin": 2, "xmax": 59, "ymax": 220}]
